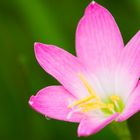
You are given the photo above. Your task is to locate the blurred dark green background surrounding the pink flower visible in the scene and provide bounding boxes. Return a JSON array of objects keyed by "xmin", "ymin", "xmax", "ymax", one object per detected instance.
[{"xmin": 0, "ymin": 0, "xmax": 140, "ymax": 140}]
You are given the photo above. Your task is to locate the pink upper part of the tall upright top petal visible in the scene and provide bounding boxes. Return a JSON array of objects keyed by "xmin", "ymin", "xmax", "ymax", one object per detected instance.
[{"xmin": 76, "ymin": 2, "xmax": 124, "ymax": 71}]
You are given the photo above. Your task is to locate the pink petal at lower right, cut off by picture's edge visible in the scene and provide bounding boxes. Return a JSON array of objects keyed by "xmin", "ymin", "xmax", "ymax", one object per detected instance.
[{"xmin": 117, "ymin": 82, "xmax": 140, "ymax": 122}]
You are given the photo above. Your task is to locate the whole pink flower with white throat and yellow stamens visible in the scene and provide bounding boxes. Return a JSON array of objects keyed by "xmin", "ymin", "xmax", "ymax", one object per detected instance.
[{"xmin": 29, "ymin": 2, "xmax": 140, "ymax": 136}]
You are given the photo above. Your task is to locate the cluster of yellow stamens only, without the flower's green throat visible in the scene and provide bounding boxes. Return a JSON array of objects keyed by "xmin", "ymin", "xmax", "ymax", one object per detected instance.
[{"xmin": 68, "ymin": 73, "xmax": 120, "ymax": 113}]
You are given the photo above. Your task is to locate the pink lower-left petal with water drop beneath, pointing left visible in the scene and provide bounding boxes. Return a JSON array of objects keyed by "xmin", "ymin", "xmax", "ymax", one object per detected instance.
[{"xmin": 29, "ymin": 86, "xmax": 83, "ymax": 122}]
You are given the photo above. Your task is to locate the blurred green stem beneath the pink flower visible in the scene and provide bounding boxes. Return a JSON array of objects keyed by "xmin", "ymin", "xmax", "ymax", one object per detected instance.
[{"xmin": 110, "ymin": 121, "xmax": 132, "ymax": 140}]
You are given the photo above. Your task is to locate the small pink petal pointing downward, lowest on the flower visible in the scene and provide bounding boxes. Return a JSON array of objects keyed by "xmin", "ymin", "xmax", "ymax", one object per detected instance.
[{"xmin": 78, "ymin": 113, "xmax": 118, "ymax": 137}]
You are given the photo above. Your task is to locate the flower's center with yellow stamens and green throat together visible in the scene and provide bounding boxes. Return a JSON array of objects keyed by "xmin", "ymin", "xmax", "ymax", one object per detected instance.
[{"xmin": 68, "ymin": 74, "xmax": 124, "ymax": 115}]
